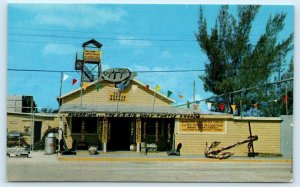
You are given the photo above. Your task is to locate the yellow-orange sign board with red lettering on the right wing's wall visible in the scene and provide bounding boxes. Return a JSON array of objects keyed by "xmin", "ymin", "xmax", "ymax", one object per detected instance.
[{"xmin": 179, "ymin": 119, "xmax": 226, "ymax": 134}]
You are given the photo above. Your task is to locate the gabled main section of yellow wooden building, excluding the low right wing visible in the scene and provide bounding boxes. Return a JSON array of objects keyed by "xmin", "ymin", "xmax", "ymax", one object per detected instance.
[{"xmin": 60, "ymin": 79, "xmax": 200, "ymax": 152}]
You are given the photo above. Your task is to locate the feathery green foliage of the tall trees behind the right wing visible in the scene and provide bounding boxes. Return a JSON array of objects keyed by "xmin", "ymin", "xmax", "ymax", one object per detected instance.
[{"xmin": 196, "ymin": 5, "xmax": 293, "ymax": 115}]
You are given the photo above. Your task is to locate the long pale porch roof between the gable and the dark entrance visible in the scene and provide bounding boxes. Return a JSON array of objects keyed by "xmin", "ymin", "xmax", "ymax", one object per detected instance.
[{"xmin": 60, "ymin": 104, "xmax": 200, "ymax": 114}]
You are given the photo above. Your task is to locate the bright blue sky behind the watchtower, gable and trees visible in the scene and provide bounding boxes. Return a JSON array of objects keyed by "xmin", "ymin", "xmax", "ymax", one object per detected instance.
[{"xmin": 7, "ymin": 4, "xmax": 294, "ymax": 110}]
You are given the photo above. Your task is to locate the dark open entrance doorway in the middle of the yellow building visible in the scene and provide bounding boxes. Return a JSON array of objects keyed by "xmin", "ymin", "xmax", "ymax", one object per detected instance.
[{"xmin": 107, "ymin": 118, "xmax": 131, "ymax": 151}]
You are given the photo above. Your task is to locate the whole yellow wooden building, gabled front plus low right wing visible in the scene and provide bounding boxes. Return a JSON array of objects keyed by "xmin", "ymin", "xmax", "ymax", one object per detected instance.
[{"xmin": 59, "ymin": 79, "xmax": 281, "ymax": 156}]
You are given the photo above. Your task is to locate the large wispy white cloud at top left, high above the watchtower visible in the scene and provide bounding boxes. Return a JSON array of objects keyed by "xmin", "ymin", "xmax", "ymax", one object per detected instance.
[{"xmin": 23, "ymin": 5, "xmax": 127, "ymax": 29}]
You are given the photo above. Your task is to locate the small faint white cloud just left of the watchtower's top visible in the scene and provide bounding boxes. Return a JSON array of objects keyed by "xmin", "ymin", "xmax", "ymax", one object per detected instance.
[{"xmin": 43, "ymin": 43, "xmax": 76, "ymax": 55}]
